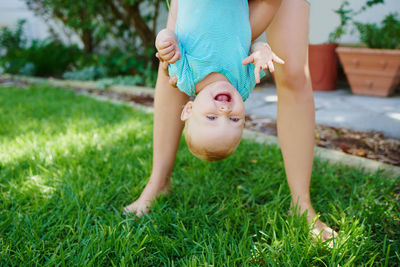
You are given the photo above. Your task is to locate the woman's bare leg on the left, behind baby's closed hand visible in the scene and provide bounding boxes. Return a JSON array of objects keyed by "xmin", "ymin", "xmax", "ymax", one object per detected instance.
[{"xmin": 125, "ymin": 1, "xmax": 189, "ymax": 216}]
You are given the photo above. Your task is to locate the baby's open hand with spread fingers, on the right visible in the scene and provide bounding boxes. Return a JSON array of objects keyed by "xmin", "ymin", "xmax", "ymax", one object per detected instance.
[{"xmin": 242, "ymin": 42, "xmax": 285, "ymax": 83}]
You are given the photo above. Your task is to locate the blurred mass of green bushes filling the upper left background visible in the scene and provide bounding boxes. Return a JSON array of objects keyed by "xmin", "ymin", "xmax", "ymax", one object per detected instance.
[{"xmin": 0, "ymin": 0, "xmax": 167, "ymax": 86}]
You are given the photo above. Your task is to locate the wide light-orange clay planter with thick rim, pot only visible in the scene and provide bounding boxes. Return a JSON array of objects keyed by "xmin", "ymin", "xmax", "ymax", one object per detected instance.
[{"xmin": 336, "ymin": 47, "xmax": 400, "ymax": 96}]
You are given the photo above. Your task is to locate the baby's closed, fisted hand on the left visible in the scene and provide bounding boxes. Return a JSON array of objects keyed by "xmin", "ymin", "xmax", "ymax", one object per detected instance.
[{"xmin": 156, "ymin": 29, "xmax": 181, "ymax": 64}]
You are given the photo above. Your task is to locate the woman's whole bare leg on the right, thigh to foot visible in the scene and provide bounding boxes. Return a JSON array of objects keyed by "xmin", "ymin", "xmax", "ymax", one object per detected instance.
[{"xmin": 267, "ymin": 0, "xmax": 333, "ymax": 240}]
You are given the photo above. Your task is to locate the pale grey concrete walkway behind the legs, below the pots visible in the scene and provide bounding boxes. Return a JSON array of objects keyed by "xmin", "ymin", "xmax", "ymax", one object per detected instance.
[{"xmin": 245, "ymin": 83, "xmax": 400, "ymax": 139}]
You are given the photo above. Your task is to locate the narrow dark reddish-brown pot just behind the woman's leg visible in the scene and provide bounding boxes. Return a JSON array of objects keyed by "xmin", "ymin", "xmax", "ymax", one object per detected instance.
[{"xmin": 308, "ymin": 43, "xmax": 338, "ymax": 91}]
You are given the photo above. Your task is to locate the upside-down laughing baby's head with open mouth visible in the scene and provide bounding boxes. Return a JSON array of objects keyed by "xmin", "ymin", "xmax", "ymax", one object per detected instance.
[{"xmin": 182, "ymin": 81, "xmax": 245, "ymax": 158}]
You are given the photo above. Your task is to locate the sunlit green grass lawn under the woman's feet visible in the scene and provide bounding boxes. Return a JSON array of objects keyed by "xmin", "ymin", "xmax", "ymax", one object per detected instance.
[{"xmin": 0, "ymin": 86, "xmax": 400, "ymax": 266}]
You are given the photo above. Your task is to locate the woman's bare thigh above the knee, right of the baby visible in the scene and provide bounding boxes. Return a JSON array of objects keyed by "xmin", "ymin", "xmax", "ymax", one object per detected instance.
[{"xmin": 266, "ymin": 0, "xmax": 310, "ymax": 79}]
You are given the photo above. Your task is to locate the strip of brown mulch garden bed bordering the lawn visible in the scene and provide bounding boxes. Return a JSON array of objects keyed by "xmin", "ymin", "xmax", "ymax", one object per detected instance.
[{"xmin": 5, "ymin": 76, "xmax": 400, "ymax": 166}]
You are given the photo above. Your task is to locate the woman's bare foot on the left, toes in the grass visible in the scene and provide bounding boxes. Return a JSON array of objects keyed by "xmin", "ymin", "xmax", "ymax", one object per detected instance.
[{"xmin": 124, "ymin": 179, "xmax": 171, "ymax": 217}]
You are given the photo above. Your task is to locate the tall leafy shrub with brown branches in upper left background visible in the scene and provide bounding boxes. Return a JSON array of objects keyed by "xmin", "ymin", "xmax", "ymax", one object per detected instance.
[{"xmin": 23, "ymin": 0, "xmax": 161, "ymax": 69}]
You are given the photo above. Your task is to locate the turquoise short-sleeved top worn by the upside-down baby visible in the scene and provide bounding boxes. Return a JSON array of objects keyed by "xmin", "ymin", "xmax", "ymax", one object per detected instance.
[{"xmin": 168, "ymin": 0, "xmax": 264, "ymax": 101}]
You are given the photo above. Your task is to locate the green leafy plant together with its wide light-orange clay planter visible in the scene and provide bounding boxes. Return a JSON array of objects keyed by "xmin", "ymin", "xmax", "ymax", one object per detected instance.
[{"xmin": 334, "ymin": 0, "xmax": 400, "ymax": 96}]
